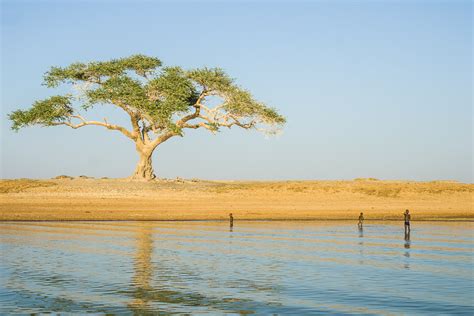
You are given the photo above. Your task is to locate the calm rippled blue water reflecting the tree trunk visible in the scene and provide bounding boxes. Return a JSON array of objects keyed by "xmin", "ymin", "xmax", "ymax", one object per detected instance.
[{"xmin": 0, "ymin": 221, "xmax": 474, "ymax": 315}]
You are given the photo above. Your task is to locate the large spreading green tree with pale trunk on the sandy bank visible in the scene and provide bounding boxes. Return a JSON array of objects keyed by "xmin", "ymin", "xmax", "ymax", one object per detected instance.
[{"xmin": 9, "ymin": 55, "xmax": 285, "ymax": 180}]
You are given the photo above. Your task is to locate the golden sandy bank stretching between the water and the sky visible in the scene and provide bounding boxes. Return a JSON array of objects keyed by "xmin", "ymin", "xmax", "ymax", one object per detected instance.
[{"xmin": 0, "ymin": 178, "xmax": 474, "ymax": 221}]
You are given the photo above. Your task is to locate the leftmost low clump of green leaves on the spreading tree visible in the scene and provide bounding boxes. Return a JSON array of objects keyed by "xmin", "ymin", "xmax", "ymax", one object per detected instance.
[{"xmin": 8, "ymin": 95, "xmax": 73, "ymax": 131}]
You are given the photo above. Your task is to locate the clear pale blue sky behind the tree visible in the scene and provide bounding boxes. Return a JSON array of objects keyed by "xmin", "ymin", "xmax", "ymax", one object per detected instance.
[{"xmin": 0, "ymin": 1, "xmax": 473, "ymax": 182}]
